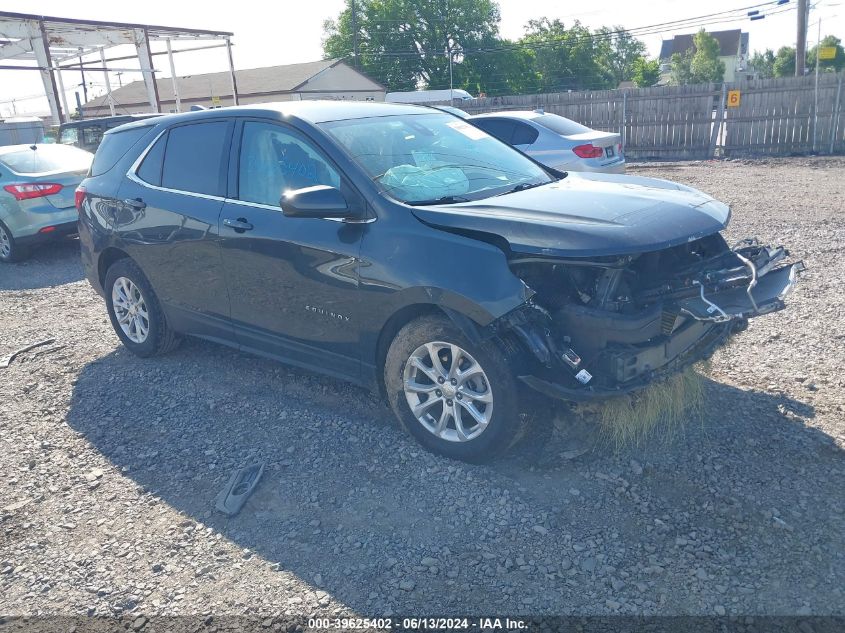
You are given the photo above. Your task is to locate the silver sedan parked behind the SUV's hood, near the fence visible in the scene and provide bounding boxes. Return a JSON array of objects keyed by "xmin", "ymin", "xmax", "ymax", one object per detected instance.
[{"xmin": 468, "ymin": 110, "xmax": 625, "ymax": 174}]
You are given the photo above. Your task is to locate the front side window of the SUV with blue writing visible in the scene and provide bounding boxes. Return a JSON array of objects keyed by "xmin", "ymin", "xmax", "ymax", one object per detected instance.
[{"xmin": 238, "ymin": 121, "xmax": 340, "ymax": 206}]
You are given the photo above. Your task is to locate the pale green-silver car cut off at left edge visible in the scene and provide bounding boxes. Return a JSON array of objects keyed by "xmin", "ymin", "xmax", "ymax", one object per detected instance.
[{"xmin": 0, "ymin": 145, "xmax": 94, "ymax": 262}]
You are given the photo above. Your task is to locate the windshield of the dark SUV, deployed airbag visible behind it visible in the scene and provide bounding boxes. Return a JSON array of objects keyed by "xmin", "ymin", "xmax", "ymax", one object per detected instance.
[{"xmin": 322, "ymin": 112, "xmax": 553, "ymax": 204}]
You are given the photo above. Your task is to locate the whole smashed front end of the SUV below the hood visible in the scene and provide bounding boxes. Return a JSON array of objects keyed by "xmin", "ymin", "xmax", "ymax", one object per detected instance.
[{"xmin": 491, "ymin": 233, "xmax": 804, "ymax": 401}]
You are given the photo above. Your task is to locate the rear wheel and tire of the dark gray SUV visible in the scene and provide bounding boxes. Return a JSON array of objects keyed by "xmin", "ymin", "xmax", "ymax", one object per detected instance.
[{"xmin": 104, "ymin": 258, "xmax": 180, "ymax": 358}]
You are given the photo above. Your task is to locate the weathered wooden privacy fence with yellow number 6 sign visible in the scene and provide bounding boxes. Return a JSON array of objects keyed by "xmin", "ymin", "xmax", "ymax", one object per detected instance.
[{"xmin": 436, "ymin": 73, "xmax": 845, "ymax": 160}]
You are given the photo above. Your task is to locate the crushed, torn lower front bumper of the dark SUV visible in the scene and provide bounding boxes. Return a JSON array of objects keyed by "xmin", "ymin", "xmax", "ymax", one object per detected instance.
[{"xmin": 518, "ymin": 242, "xmax": 804, "ymax": 402}]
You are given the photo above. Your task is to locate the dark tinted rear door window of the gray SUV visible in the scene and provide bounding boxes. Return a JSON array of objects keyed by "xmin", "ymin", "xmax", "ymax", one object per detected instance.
[{"xmin": 161, "ymin": 121, "xmax": 229, "ymax": 196}]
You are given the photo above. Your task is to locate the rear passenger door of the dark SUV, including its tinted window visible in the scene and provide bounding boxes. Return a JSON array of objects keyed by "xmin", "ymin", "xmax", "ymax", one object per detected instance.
[{"xmin": 113, "ymin": 118, "xmax": 234, "ymax": 339}]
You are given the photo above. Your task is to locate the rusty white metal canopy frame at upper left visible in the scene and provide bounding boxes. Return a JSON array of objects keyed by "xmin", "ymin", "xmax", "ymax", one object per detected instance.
[{"xmin": 0, "ymin": 11, "xmax": 238, "ymax": 125}]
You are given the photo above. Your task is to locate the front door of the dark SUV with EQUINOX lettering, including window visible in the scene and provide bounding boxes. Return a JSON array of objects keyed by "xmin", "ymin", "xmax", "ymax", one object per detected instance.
[{"xmin": 220, "ymin": 121, "xmax": 367, "ymax": 379}]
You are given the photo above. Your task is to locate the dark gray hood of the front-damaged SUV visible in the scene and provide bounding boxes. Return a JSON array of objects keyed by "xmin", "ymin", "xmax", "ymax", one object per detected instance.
[{"xmin": 413, "ymin": 173, "xmax": 730, "ymax": 257}]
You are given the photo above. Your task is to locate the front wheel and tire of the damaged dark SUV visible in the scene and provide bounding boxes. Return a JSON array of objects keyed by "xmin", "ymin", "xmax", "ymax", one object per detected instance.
[{"xmin": 384, "ymin": 316, "xmax": 522, "ymax": 463}]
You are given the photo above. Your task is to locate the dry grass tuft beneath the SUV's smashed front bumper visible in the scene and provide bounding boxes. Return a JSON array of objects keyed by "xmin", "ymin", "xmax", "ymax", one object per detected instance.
[{"xmin": 596, "ymin": 368, "xmax": 704, "ymax": 451}]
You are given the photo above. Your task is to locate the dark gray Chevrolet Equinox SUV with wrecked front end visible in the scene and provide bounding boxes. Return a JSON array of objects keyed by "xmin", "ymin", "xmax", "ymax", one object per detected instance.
[{"xmin": 78, "ymin": 101, "xmax": 801, "ymax": 460}]
